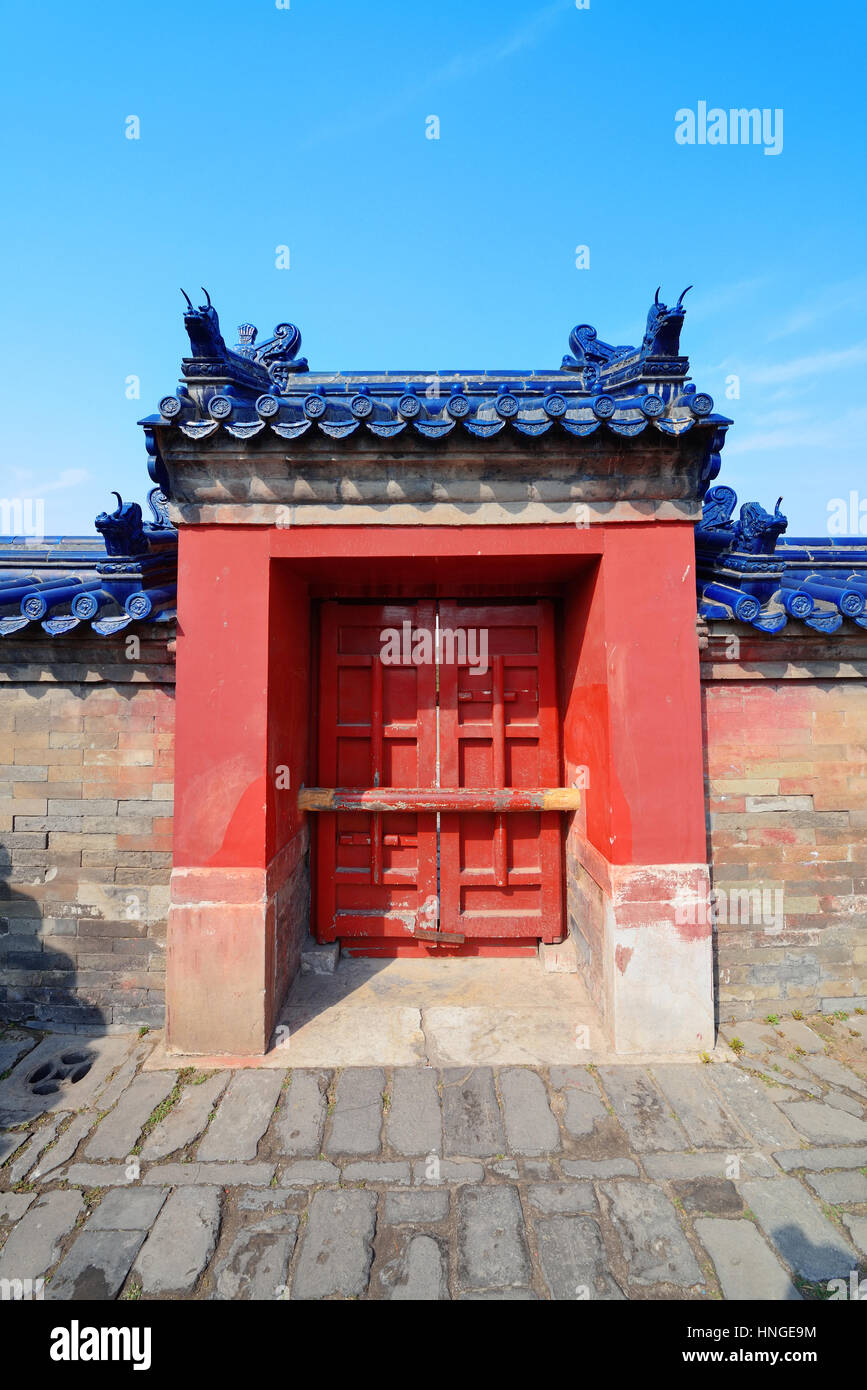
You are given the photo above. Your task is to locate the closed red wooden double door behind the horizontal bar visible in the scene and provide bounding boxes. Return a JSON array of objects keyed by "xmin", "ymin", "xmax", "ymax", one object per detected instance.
[{"xmin": 317, "ymin": 600, "xmax": 563, "ymax": 955}]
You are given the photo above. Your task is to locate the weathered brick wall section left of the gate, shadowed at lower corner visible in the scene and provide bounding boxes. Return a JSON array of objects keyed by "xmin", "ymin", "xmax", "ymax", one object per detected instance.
[{"xmin": 0, "ymin": 624, "xmax": 174, "ymax": 1027}]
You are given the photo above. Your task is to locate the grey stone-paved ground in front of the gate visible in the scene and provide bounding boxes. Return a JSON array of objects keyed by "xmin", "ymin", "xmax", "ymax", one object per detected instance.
[{"xmin": 0, "ymin": 1012, "xmax": 867, "ymax": 1300}]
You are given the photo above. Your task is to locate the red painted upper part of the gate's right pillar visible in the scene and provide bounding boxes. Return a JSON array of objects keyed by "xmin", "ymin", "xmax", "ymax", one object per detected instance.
[{"xmin": 561, "ymin": 523, "xmax": 706, "ymax": 865}]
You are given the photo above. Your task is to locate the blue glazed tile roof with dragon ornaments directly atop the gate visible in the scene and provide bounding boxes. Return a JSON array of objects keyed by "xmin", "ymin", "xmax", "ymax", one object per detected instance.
[{"xmin": 142, "ymin": 291, "xmax": 731, "ymax": 461}]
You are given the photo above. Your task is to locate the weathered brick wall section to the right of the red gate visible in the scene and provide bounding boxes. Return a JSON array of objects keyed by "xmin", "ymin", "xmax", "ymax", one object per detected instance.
[{"xmin": 702, "ymin": 624, "xmax": 867, "ymax": 1022}]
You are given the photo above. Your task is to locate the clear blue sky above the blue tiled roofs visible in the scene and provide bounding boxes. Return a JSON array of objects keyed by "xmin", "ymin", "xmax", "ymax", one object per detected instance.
[{"xmin": 0, "ymin": 0, "xmax": 867, "ymax": 534}]
